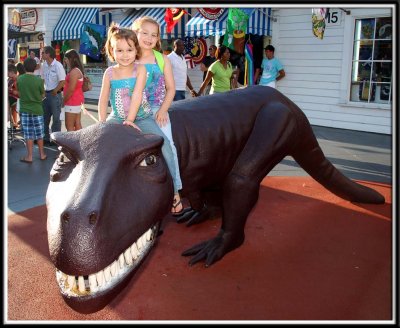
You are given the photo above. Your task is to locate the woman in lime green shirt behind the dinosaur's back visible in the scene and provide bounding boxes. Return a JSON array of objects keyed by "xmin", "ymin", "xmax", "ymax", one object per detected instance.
[{"xmin": 198, "ymin": 46, "xmax": 237, "ymax": 95}]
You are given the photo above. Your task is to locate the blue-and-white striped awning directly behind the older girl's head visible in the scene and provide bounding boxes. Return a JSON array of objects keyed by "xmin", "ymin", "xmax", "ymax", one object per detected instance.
[{"xmin": 120, "ymin": 8, "xmax": 197, "ymax": 39}]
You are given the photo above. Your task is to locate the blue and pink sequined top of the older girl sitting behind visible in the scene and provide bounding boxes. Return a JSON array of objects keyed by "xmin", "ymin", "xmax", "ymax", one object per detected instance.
[{"xmin": 144, "ymin": 63, "xmax": 167, "ymax": 107}]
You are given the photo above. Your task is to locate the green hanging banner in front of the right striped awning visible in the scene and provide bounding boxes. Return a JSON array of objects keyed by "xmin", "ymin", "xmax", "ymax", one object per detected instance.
[{"xmin": 223, "ymin": 8, "xmax": 254, "ymax": 54}]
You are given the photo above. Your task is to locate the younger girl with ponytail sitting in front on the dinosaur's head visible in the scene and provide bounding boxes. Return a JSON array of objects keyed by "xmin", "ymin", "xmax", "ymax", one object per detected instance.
[{"xmin": 98, "ymin": 23, "xmax": 183, "ymax": 213}]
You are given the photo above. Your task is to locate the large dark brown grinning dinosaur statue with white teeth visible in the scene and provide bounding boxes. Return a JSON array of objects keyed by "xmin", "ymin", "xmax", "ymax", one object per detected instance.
[{"xmin": 46, "ymin": 86, "xmax": 385, "ymax": 313}]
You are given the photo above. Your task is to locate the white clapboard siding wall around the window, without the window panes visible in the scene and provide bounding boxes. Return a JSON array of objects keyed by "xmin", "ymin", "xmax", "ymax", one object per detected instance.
[{"xmin": 272, "ymin": 8, "xmax": 392, "ymax": 134}]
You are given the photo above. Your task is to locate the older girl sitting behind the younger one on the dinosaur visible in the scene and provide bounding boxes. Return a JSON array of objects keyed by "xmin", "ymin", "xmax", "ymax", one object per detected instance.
[{"xmin": 132, "ymin": 16, "xmax": 185, "ymax": 215}]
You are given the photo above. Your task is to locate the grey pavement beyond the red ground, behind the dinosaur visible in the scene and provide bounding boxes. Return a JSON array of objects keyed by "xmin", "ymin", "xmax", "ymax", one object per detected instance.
[{"xmin": 6, "ymin": 104, "xmax": 392, "ymax": 215}]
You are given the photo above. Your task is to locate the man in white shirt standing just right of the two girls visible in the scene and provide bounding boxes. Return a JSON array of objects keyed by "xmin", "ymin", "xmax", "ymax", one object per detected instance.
[{"xmin": 168, "ymin": 39, "xmax": 197, "ymax": 101}]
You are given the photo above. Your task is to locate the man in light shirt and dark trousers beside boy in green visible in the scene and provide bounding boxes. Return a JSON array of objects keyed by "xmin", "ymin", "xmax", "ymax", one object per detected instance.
[{"xmin": 42, "ymin": 46, "xmax": 66, "ymax": 146}]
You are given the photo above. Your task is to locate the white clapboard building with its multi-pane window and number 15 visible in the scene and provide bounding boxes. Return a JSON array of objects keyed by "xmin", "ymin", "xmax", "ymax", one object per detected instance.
[{"xmin": 273, "ymin": 5, "xmax": 396, "ymax": 134}]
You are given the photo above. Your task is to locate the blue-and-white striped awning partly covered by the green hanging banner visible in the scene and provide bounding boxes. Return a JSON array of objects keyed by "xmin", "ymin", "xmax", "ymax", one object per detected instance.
[{"xmin": 186, "ymin": 8, "xmax": 271, "ymax": 37}]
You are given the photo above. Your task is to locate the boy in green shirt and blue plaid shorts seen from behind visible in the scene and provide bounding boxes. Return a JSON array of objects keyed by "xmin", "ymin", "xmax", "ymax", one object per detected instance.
[{"xmin": 17, "ymin": 57, "xmax": 47, "ymax": 164}]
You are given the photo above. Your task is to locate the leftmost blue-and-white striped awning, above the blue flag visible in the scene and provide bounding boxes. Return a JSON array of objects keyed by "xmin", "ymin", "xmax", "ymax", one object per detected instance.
[{"xmin": 53, "ymin": 8, "xmax": 112, "ymax": 41}]
